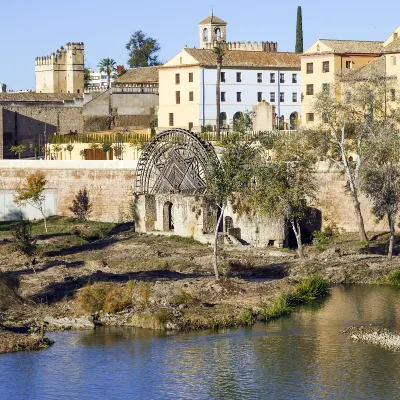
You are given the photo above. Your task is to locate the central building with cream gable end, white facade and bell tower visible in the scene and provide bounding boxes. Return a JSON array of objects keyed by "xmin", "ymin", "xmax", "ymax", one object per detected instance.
[{"xmin": 158, "ymin": 16, "xmax": 301, "ymax": 131}]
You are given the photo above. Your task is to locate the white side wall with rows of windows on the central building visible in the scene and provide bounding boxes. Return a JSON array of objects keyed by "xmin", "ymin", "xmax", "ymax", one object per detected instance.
[{"xmin": 199, "ymin": 68, "xmax": 301, "ymax": 125}]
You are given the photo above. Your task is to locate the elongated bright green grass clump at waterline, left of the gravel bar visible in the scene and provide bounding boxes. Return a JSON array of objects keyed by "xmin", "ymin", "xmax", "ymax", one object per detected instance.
[{"xmin": 261, "ymin": 276, "xmax": 329, "ymax": 321}]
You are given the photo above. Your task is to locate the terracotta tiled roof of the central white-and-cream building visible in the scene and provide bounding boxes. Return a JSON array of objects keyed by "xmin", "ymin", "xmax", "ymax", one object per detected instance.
[{"xmin": 180, "ymin": 48, "xmax": 301, "ymax": 68}]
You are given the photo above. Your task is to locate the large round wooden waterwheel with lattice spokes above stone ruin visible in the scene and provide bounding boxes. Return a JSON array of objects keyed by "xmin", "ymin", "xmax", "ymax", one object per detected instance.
[{"xmin": 135, "ymin": 128, "xmax": 219, "ymax": 195}]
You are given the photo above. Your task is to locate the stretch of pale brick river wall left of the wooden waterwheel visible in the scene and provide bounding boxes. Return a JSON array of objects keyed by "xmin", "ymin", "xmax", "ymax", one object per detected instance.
[{"xmin": 0, "ymin": 160, "xmax": 136, "ymax": 222}]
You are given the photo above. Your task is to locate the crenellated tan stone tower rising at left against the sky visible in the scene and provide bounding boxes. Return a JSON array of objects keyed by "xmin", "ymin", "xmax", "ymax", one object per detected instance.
[{"xmin": 35, "ymin": 43, "xmax": 85, "ymax": 93}]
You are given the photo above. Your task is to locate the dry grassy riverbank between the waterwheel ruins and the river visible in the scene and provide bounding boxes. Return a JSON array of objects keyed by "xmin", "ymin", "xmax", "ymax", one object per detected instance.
[{"xmin": 0, "ymin": 217, "xmax": 400, "ymax": 352}]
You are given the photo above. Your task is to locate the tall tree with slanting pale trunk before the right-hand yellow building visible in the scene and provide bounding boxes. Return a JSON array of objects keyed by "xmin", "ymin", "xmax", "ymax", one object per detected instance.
[{"xmin": 314, "ymin": 65, "xmax": 399, "ymax": 241}]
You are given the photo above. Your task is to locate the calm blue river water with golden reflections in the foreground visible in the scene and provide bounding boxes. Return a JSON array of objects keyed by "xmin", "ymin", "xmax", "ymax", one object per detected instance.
[{"xmin": 0, "ymin": 285, "xmax": 400, "ymax": 400}]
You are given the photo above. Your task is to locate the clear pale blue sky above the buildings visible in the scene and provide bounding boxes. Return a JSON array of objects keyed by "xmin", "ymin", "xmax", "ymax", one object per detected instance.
[{"xmin": 0, "ymin": 0, "xmax": 400, "ymax": 90}]
